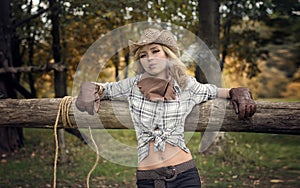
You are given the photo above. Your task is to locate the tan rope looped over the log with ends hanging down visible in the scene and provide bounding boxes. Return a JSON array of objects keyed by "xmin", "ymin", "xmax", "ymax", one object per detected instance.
[{"xmin": 53, "ymin": 96, "xmax": 99, "ymax": 188}]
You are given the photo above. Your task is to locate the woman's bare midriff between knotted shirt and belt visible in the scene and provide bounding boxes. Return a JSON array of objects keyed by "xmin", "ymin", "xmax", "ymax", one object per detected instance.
[{"xmin": 138, "ymin": 141, "xmax": 192, "ymax": 170}]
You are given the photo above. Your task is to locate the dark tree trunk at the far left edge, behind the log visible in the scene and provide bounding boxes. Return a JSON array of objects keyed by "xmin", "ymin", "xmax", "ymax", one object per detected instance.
[{"xmin": 0, "ymin": 0, "xmax": 24, "ymax": 158}]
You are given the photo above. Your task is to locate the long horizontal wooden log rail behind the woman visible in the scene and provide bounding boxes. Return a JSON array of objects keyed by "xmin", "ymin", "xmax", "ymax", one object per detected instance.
[{"xmin": 0, "ymin": 98, "xmax": 300, "ymax": 134}]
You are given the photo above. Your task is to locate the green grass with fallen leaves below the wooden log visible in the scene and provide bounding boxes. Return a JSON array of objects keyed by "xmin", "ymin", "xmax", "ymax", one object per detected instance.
[{"xmin": 0, "ymin": 129, "xmax": 300, "ymax": 188}]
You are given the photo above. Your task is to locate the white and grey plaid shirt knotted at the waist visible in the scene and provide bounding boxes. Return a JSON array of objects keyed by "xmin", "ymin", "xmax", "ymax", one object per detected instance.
[{"xmin": 102, "ymin": 75, "xmax": 217, "ymax": 162}]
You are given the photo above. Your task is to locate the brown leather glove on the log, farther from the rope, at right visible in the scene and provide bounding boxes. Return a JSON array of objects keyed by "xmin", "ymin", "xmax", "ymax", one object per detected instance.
[{"xmin": 229, "ymin": 87, "xmax": 256, "ymax": 119}]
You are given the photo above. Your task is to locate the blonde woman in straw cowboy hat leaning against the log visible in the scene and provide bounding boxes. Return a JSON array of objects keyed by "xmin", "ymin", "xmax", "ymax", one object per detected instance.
[{"xmin": 76, "ymin": 28, "xmax": 256, "ymax": 188}]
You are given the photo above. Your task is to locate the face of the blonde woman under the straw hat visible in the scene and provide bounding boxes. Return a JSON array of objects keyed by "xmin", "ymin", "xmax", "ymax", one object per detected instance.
[{"xmin": 139, "ymin": 44, "xmax": 168, "ymax": 79}]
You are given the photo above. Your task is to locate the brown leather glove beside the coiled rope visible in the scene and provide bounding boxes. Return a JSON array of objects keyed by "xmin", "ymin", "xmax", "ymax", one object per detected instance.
[{"xmin": 75, "ymin": 82, "xmax": 103, "ymax": 115}]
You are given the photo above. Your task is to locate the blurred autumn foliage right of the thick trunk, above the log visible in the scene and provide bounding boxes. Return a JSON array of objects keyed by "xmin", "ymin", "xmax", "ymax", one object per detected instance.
[{"xmin": 221, "ymin": 0, "xmax": 300, "ymax": 98}]
